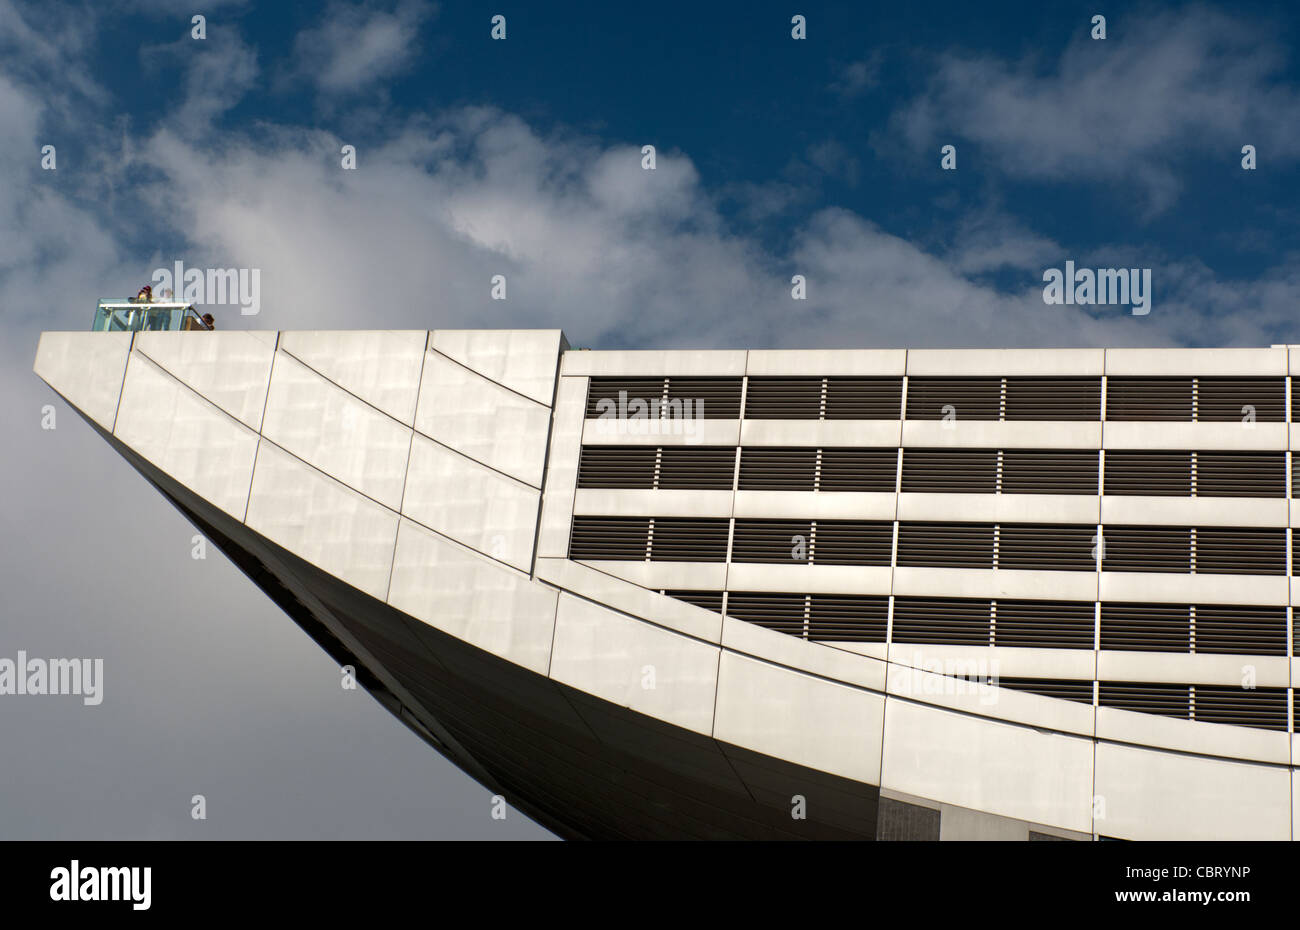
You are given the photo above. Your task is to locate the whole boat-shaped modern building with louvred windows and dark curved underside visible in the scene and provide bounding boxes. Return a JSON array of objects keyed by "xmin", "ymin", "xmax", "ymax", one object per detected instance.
[{"xmin": 35, "ymin": 330, "xmax": 1300, "ymax": 840}]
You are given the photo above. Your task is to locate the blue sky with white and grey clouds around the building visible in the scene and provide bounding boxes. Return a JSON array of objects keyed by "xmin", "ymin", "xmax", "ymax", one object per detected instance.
[{"xmin": 0, "ymin": 0, "xmax": 1300, "ymax": 839}]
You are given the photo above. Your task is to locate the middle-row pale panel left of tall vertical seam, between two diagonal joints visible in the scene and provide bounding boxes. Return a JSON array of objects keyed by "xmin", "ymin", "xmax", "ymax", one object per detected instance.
[{"xmin": 402, "ymin": 433, "xmax": 541, "ymax": 571}]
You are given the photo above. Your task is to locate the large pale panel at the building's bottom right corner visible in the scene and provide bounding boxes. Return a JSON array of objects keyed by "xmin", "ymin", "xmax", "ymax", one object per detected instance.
[{"xmin": 1096, "ymin": 743, "xmax": 1291, "ymax": 840}]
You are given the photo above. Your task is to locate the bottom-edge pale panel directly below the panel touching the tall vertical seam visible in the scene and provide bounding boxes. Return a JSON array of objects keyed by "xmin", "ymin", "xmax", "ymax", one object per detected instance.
[{"xmin": 389, "ymin": 519, "xmax": 558, "ymax": 675}]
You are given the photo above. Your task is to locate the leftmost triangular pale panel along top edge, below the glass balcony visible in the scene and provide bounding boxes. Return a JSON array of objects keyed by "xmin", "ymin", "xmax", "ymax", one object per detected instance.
[{"xmin": 135, "ymin": 329, "xmax": 277, "ymax": 429}]
